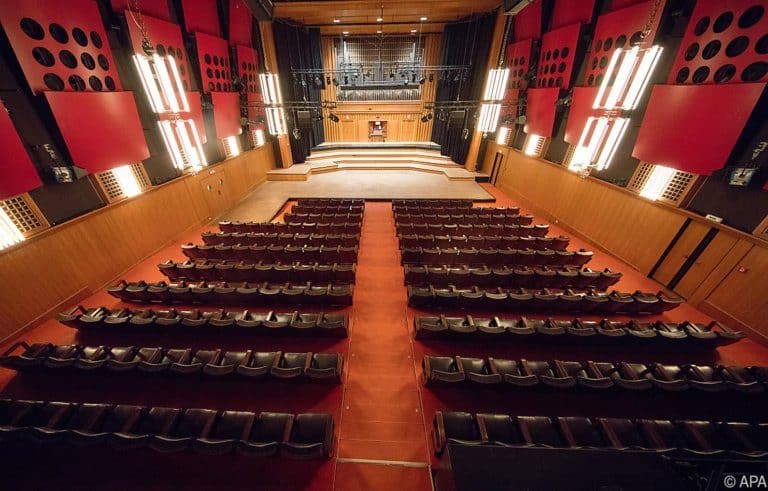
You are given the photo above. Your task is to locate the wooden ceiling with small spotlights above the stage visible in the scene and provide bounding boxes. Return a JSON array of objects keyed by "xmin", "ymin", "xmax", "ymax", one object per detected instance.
[{"xmin": 275, "ymin": 0, "xmax": 501, "ymax": 35}]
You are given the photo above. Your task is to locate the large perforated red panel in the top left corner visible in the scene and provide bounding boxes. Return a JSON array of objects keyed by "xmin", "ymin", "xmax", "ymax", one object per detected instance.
[{"xmin": 0, "ymin": 0, "xmax": 122, "ymax": 93}]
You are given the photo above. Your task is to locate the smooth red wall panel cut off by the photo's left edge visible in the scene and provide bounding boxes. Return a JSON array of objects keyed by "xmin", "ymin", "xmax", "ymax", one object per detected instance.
[{"xmin": 0, "ymin": 102, "xmax": 42, "ymax": 199}]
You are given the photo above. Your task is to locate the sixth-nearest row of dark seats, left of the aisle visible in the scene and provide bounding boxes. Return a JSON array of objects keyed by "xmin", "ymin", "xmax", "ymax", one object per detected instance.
[{"xmin": 181, "ymin": 244, "xmax": 357, "ymax": 264}]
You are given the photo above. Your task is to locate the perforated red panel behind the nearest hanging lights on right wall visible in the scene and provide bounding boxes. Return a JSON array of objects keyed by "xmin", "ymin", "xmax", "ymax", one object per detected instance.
[{"xmin": 584, "ymin": 2, "xmax": 661, "ymax": 87}]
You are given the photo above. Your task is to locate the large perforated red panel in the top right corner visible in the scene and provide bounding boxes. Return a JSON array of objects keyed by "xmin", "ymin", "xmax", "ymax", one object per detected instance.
[{"xmin": 668, "ymin": 0, "xmax": 768, "ymax": 84}]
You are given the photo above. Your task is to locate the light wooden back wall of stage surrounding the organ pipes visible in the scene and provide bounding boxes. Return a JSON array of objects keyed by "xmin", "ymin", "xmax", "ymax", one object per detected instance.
[{"xmin": 321, "ymin": 34, "xmax": 441, "ymax": 143}]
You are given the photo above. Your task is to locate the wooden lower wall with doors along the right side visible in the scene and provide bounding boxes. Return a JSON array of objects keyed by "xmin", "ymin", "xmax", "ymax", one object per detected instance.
[{"xmin": 482, "ymin": 142, "xmax": 768, "ymax": 342}]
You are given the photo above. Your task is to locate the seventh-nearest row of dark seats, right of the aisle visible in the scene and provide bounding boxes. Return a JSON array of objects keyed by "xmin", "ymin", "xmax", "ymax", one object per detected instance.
[{"xmin": 400, "ymin": 234, "xmax": 571, "ymax": 251}]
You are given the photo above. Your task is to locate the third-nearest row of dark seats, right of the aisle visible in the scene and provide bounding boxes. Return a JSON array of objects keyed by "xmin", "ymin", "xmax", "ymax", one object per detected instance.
[{"xmin": 413, "ymin": 315, "xmax": 746, "ymax": 347}]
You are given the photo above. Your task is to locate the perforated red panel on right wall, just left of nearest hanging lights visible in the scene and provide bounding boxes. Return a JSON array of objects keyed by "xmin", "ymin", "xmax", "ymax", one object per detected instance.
[{"xmin": 536, "ymin": 24, "xmax": 581, "ymax": 89}]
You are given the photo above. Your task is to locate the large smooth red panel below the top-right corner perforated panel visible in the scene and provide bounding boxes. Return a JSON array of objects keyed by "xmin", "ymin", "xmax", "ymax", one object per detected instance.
[{"xmin": 632, "ymin": 83, "xmax": 766, "ymax": 175}]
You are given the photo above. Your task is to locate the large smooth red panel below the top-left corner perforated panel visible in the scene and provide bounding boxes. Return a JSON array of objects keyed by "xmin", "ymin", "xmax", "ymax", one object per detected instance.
[{"xmin": 45, "ymin": 92, "xmax": 149, "ymax": 173}]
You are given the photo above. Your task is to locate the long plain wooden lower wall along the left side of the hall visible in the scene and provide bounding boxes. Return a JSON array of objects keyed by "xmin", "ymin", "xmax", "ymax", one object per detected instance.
[{"xmin": 0, "ymin": 145, "xmax": 274, "ymax": 340}]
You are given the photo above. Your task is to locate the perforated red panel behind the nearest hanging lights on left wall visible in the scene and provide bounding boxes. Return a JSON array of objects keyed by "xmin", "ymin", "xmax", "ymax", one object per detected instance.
[{"xmin": 126, "ymin": 14, "xmax": 193, "ymax": 90}]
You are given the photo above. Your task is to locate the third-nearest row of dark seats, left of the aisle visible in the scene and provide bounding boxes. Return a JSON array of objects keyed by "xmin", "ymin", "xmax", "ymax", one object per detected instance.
[{"xmin": 58, "ymin": 306, "xmax": 349, "ymax": 338}]
